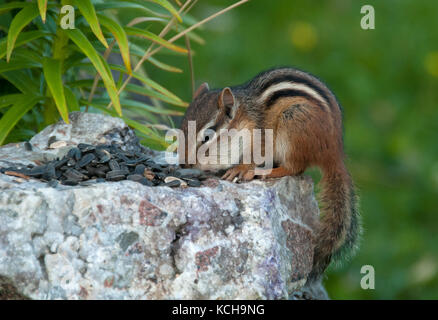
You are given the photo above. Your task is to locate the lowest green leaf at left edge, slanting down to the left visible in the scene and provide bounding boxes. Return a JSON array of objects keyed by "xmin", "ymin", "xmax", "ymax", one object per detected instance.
[{"xmin": 0, "ymin": 94, "xmax": 42, "ymax": 145}]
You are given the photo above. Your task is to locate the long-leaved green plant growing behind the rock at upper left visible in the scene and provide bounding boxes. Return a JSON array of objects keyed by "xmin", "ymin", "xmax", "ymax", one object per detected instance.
[{"xmin": 0, "ymin": 0, "xmax": 198, "ymax": 148}]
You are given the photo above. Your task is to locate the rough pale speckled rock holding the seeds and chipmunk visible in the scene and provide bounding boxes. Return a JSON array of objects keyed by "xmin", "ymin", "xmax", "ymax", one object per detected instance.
[{"xmin": 0, "ymin": 114, "xmax": 327, "ymax": 299}]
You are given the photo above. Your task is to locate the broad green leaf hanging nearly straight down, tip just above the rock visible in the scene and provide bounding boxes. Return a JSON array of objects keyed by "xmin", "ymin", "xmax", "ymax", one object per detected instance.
[{"xmin": 43, "ymin": 58, "xmax": 68, "ymax": 123}]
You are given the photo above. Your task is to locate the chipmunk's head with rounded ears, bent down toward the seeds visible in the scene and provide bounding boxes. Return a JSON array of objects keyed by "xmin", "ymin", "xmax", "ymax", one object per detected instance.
[{"xmin": 178, "ymin": 83, "xmax": 237, "ymax": 171}]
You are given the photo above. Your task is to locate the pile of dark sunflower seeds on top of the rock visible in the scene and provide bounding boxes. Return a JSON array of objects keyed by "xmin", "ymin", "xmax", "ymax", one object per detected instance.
[{"xmin": 0, "ymin": 143, "xmax": 206, "ymax": 187}]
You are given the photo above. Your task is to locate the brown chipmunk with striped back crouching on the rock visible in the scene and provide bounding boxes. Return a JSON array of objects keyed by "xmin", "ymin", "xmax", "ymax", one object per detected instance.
[{"xmin": 180, "ymin": 68, "xmax": 360, "ymax": 281}]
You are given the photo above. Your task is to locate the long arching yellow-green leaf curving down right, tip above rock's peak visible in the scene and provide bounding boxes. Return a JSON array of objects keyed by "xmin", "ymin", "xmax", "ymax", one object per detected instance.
[{"xmin": 66, "ymin": 29, "xmax": 122, "ymax": 116}]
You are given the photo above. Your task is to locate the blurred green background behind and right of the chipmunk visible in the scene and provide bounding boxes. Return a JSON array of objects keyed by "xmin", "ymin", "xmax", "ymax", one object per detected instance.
[{"xmin": 149, "ymin": 0, "xmax": 438, "ymax": 299}]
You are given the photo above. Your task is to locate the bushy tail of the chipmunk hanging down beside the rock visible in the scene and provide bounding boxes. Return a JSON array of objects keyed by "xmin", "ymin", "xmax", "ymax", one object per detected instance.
[{"xmin": 308, "ymin": 165, "xmax": 361, "ymax": 281}]
